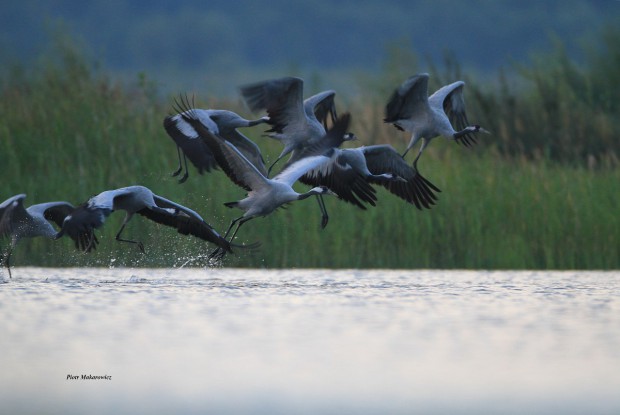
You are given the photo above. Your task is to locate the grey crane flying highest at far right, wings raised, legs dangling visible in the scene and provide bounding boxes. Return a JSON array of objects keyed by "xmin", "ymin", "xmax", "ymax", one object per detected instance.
[{"xmin": 384, "ymin": 73, "xmax": 488, "ymax": 166}]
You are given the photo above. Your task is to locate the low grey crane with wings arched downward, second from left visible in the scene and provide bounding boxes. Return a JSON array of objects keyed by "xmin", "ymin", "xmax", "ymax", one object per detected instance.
[{"xmin": 56, "ymin": 185, "xmax": 248, "ymax": 253}]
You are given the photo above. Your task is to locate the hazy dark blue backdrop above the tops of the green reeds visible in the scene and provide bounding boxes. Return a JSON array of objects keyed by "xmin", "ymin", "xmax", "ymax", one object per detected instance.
[{"xmin": 0, "ymin": 0, "xmax": 620, "ymax": 87}]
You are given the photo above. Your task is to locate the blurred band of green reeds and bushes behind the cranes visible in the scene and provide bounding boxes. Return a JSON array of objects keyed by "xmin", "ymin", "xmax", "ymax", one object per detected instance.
[{"xmin": 0, "ymin": 29, "xmax": 620, "ymax": 269}]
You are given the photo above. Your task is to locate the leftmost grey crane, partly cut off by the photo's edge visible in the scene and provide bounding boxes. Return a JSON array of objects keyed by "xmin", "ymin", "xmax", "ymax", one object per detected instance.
[{"xmin": 0, "ymin": 194, "xmax": 98, "ymax": 277}]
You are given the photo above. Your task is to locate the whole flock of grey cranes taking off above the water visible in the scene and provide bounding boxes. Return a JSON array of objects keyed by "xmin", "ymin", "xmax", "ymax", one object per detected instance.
[{"xmin": 0, "ymin": 73, "xmax": 488, "ymax": 276}]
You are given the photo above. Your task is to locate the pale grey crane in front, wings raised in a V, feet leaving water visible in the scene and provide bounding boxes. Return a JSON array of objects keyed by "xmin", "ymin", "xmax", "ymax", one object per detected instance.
[{"xmin": 177, "ymin": 103, "xmax": 350, "ymax": 258}]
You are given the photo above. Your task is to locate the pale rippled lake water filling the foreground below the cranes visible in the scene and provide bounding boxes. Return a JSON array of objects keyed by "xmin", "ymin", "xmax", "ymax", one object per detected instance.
[{"xmin": 0, "ymin": 268, "xmax": 620, "ymax": 414}]
